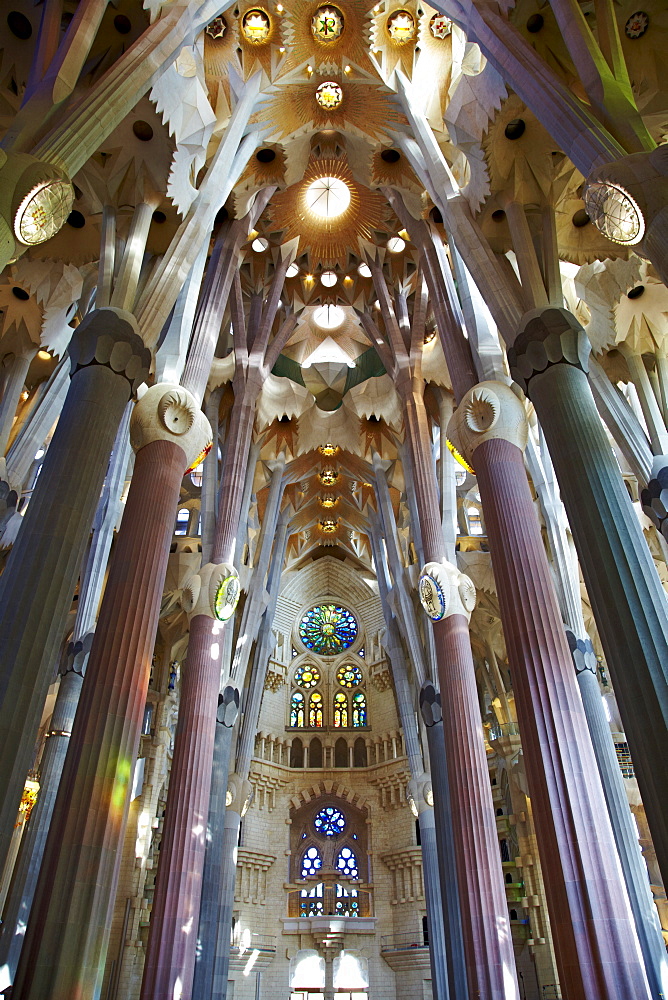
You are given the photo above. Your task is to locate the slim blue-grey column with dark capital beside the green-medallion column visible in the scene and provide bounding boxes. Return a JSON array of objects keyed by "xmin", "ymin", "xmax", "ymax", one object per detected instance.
[{"xmin": 192, "ymin": 685, "xmax": 239, "ymax": 1000}]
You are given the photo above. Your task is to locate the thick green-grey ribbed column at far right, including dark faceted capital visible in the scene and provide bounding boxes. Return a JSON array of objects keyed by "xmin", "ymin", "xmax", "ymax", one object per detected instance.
[{"xmin": 508, "ymin": 309, "xmax": 668, "ymax": 882}]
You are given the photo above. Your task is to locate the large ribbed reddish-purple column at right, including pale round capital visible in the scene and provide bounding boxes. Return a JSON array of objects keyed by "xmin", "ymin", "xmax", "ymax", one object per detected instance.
[{"xmin": 449, "ymin": 382, "xmax": 649, "ymax": 1000}]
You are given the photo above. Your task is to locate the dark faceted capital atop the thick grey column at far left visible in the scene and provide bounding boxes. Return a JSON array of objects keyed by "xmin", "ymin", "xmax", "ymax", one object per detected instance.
[{"xmin": 69, "ymin": 306, "xmax": 151, "ymax": 395}]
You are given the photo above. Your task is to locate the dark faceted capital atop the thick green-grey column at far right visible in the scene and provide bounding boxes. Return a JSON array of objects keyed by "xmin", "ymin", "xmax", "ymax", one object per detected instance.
[{"xmin": 508, "ymin": 306, "xmax": 591, "ymax": 396}]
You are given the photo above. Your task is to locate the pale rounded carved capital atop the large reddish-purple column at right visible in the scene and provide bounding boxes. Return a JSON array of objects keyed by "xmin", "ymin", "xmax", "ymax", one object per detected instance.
[{"xmin": 448, "ymin": 382, "xmax": 528, "ymax": 465}]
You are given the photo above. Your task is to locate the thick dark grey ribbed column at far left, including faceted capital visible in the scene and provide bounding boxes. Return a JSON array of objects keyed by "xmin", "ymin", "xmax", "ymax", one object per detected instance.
[{"xmin": 0, "ymin": 309, "xmax": 150, "ymax": 880}]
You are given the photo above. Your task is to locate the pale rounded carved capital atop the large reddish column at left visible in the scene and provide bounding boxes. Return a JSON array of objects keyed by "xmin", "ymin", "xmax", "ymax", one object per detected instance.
[{"xmin": 130, "ymin": 382, "xmax": 211, "ymax": 467}]
